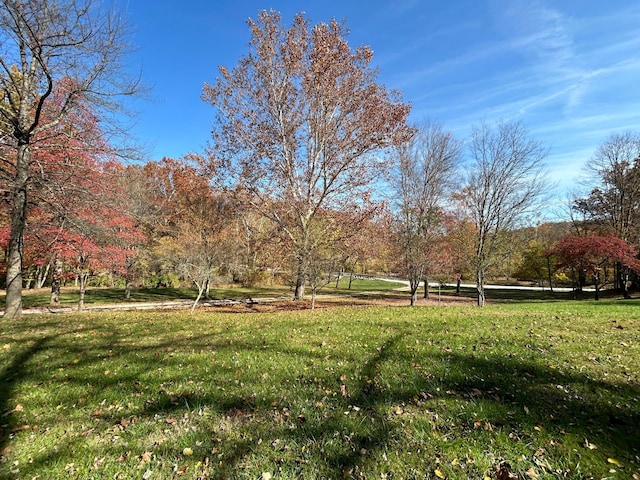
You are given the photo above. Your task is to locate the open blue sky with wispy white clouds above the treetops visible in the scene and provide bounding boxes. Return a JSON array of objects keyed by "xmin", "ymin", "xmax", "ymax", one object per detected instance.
[{"xmin": 119, "ymin": 0, "xmax": 640, "ymax": 206}]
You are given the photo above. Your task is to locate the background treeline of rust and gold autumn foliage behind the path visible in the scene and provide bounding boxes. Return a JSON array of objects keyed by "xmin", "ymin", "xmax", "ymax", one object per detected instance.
[{"xmin": 1, "ymin": 125, "xmax": 640, "ymax": 303}]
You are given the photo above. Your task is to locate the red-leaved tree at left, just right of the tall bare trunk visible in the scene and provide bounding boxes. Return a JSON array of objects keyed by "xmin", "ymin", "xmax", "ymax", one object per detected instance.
[{"xmin": 32, "ymin": 157, "xmax": 144, "ymax": 309}]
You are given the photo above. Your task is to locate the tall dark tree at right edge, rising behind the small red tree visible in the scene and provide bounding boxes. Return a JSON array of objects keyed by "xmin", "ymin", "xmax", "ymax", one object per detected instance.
[{"xmin": 573, "ymin": 132, "xmax": 640, "ymax": 294}]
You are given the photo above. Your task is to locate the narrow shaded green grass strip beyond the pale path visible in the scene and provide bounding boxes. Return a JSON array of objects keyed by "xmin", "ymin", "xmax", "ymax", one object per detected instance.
[{"xmin": 0, "ymin": 278, "xmax": 400, "ymax": 308}]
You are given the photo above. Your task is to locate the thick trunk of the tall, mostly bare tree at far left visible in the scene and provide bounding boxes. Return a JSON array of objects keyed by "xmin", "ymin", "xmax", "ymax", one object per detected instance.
[{"xmin": 4, "ymin": 140, "xmax": 30, "ymax": 318}]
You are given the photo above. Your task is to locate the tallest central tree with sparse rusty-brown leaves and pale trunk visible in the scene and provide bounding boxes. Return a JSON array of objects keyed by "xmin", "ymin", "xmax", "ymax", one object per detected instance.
[{"xmin": 203, "ymin": 11, "xmax": 411, "ymax": 299}]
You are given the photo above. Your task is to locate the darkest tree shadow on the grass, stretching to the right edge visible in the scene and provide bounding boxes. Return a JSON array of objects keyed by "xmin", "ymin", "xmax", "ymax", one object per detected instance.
[{"xmin": 422, "ymin": 353, "xmax": 640, "ymax": 458}]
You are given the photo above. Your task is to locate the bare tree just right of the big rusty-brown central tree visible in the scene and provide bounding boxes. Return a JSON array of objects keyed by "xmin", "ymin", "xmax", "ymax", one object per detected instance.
[{"xmin": 393, "ymin": 122, "xmax": 462, "ymax": 305}]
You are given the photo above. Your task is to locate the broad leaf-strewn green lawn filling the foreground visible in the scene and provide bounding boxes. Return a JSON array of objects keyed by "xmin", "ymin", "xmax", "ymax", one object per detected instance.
[{"xmin": 0, "ymin": 300, "xmax": 640, "ymax": 480}]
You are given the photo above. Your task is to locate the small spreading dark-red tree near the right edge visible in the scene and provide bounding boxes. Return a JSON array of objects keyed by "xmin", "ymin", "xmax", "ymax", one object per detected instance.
[{"xmin": 550, "ymin": 234, "xmax": 640, "ymax": 300}]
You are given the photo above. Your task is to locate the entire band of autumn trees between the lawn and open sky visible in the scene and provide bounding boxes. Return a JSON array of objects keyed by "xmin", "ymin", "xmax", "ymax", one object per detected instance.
[{"xmin": 0, "ymin": 0, "xmax": 640, "ymax": 317}]
